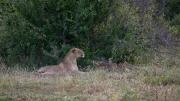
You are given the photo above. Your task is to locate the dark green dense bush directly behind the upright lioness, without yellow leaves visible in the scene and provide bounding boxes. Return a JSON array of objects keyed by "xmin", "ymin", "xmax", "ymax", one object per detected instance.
[{"xmin": 0, "ymin": 0, "xmax": 111, "ymax": 68}]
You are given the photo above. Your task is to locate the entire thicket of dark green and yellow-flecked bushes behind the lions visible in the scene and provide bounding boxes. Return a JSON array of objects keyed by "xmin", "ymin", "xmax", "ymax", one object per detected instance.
[{"xmin": 0, "ymin": 0, "xmax": 158, "ymax": 68}]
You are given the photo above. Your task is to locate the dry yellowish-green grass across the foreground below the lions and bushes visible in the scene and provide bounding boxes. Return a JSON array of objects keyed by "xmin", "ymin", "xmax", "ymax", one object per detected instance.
[{"xmin": 0, "ymin": 56, "xmax": 180, "ymax": 101}]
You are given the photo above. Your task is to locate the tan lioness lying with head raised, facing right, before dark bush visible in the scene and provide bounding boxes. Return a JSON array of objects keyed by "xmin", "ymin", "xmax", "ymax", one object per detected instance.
[{"xmin": 36, "ymin": 48, "xmax": 85, "ymax": 75}]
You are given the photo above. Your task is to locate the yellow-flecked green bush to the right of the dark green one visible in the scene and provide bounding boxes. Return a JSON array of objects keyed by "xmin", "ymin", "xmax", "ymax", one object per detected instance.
[{"xmin": 108, "ymin": 1, "xmax": 152, "ymax": 62}]
